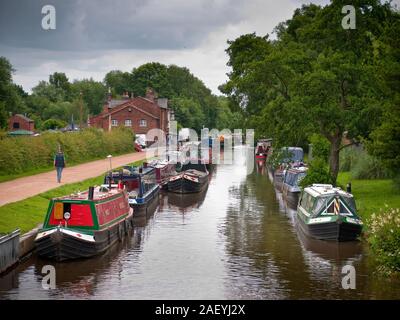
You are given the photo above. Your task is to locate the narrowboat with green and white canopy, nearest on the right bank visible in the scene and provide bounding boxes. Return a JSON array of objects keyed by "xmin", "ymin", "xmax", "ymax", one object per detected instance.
[{"xmin": 297, "ymin": 184, "xmax": 363, "ymax": 241}]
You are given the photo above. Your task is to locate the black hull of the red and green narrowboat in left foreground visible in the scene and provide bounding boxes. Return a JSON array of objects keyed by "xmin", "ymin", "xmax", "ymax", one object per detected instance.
[{"xmin": 35, "ymin": 211, "xmax": 133, "ymax": 261}]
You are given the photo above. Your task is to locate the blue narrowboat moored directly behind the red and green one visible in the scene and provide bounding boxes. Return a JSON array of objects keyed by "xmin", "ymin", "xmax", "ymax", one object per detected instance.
[{"xmin": 104, "ymin": 163, "xmax": 160, "ymax": 218}]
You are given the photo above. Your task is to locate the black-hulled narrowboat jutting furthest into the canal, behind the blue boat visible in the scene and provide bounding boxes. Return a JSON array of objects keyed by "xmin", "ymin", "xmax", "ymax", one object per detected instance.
[{"xmin": 168, "ymin": 161, "xmax": 209, "ymax": 193}]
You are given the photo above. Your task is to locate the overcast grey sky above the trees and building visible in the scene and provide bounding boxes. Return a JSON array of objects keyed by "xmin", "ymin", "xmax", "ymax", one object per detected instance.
[{"xmin": 0, "ymin": 0, "xmax": 400, "ymax": 94}]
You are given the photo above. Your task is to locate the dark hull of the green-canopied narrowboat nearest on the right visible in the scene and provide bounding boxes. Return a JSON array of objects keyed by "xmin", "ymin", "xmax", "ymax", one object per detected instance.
[{"xmin": 297, "ymin": 215, "xmax": 362, "ymax": 241}]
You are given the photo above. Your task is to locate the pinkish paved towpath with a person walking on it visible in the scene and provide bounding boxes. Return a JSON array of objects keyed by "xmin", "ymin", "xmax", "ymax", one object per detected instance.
[{"xmin": 0, "ymin": 152, "xmax": 146, "ymax": 206}]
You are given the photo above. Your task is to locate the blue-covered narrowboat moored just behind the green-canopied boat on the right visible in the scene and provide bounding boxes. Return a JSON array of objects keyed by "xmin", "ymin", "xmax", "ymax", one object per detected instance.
[{"xmin": 282, "ymin": 167, "xmax": 308, "ymax": 208}]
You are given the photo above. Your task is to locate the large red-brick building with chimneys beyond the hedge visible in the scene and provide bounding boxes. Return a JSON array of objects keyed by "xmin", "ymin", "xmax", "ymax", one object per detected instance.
[{"xmin": 88, "ymin": 89, "xmax": 170, "ymax": 134}]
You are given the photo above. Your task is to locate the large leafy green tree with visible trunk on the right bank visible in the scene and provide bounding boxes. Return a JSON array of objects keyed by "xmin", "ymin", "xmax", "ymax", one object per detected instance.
[{"xmin": 222, "ymin": 0, "xmax": 398, "ymax": 180}]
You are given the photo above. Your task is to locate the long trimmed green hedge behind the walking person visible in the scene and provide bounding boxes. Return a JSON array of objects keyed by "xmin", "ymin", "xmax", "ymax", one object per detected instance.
[{"xmin": 0, "ymin": 128, "xmax": 134, "ymax": 175}]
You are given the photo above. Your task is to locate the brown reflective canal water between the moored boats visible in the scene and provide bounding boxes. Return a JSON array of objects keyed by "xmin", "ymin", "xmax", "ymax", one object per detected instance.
[{"xmin": 0, "ymin": 148, "xmax": 400, "ymax": 299}]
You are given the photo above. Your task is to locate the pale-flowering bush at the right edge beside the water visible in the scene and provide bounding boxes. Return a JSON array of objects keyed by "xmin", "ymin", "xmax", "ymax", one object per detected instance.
[{"xmin": 367, "ymin": 208, "xmax": 400, "ymax": 275}]
